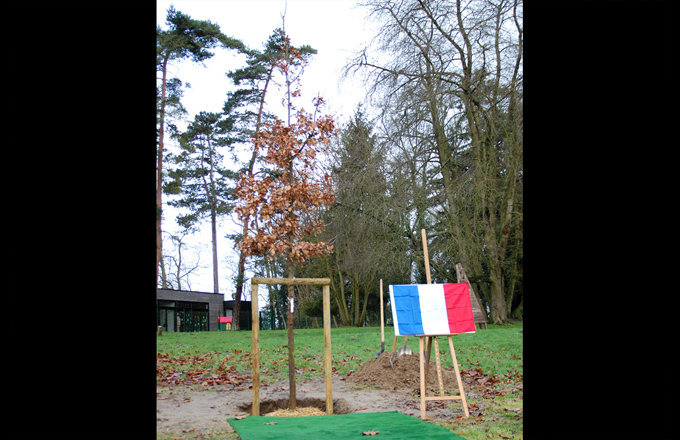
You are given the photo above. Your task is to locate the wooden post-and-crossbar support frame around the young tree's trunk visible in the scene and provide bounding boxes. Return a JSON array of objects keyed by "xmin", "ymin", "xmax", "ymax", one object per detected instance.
[{"xmin": 251, "ymin": 277, "xmax": 333, "ymax": 416}]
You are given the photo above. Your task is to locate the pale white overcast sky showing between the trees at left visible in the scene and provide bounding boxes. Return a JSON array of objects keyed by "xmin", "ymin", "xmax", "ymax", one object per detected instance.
[{"xmin": 156, "ymin": 0, "xmax": 382, "ymax": 300}]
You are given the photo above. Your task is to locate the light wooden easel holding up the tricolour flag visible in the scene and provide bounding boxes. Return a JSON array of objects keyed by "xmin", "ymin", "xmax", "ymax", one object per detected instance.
[{"xmin": 416, "ymin": 229, "xmax": 470, "ymax": 419}]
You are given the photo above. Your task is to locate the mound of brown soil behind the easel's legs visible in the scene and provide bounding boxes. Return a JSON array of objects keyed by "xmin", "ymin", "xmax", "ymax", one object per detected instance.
[{"xmin": 346, "ymin": 351, "xmax": 458, "ymax": 393}]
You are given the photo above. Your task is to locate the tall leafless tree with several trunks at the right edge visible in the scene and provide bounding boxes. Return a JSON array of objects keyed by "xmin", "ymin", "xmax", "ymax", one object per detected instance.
[{"xmin": 346, "ymin": 0, "xmax": 523, "ymax": 323}]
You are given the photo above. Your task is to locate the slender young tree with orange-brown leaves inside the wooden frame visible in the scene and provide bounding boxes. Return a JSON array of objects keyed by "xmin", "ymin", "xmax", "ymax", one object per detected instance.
[{"xmin": 235, "ymin": 31, "xmax": 337, "ymax": 409}]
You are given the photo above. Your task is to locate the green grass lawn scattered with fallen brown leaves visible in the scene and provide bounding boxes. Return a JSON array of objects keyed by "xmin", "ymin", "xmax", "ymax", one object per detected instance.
[{"xmin": 157, "ymin": 322, "xmax": 523, "ymax": 440}]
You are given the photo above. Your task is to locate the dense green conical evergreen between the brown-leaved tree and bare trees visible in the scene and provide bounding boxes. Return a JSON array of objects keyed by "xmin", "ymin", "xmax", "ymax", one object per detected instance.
[{"xmin": 327, "ymin": 108, "xmax": 395, "ymax": 326}]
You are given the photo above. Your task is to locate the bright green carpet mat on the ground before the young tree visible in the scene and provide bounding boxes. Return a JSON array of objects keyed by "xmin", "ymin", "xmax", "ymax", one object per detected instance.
[{"xmin": 228, "ymin": 411, "xmax": 464, "ymax": 440}]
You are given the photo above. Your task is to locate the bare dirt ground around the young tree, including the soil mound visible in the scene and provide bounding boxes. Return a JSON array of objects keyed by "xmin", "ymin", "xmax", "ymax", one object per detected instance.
[{"xmin": 156, "ymin": 351, "xmax": 469, "ymax": 435}]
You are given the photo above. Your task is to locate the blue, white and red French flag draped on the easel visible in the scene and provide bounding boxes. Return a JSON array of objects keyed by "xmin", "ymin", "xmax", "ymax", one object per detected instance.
[{"xmin": 389, "ymin": 283, "xmax": 475, "ymax": 336}]
